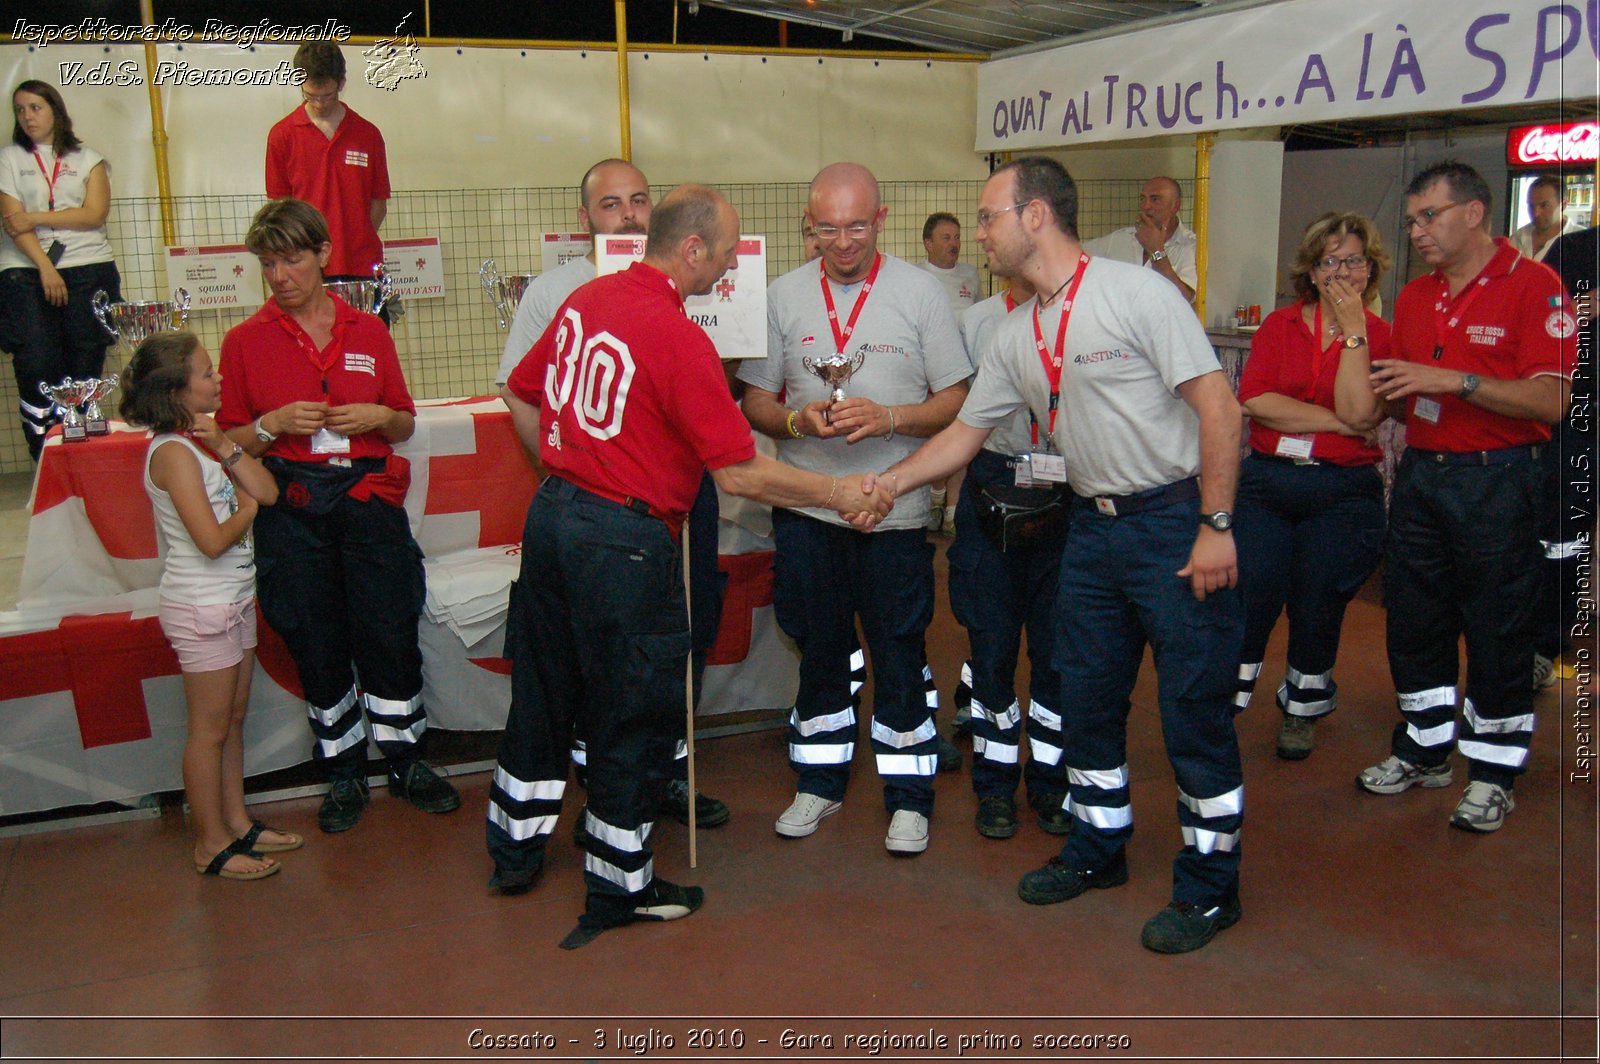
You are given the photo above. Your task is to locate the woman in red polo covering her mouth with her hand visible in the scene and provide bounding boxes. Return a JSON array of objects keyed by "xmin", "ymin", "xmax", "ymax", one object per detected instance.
[{"xmin": 1234, "ymin": 211, "xmax": 1389, "ymax": 760}]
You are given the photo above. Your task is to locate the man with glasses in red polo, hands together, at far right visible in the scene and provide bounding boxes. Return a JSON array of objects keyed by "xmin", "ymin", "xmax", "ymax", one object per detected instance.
[{"xmin": 1355, "ymin": 162, "xmax": 1578, "ymax": 832}]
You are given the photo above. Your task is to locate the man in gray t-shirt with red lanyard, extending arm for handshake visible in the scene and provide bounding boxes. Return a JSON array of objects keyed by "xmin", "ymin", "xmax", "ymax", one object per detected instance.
[{"xmin": 880, "ymin": 157, "xmax": 1243, "ymax": 954}]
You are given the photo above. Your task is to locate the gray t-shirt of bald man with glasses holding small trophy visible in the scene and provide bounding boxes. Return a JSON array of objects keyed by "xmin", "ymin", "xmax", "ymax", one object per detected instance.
[{"xmin": 739, "ymin": 254, "xmax": 973, "ymax": 530}]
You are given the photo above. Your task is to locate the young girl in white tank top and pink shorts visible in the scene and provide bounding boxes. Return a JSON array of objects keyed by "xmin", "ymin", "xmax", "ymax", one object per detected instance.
[{"xmin": 122, "ymin": 333, "xmax": 306, "ymax": 880}]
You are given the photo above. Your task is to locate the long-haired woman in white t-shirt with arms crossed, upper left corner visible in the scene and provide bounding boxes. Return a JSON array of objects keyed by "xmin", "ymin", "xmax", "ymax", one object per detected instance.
[{"xmin": 0, "ymin": 80, "xmax": 122, "ymax": 461}]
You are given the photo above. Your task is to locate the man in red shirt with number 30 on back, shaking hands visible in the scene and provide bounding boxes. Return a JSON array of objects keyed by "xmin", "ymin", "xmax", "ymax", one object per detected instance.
[{"xmin": 486, "ymin": 186, "xmax": 890, "ymax": 949}]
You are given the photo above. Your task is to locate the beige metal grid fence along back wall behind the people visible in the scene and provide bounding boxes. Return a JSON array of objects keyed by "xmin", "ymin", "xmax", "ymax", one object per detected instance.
[{"xmin": 0, "ymin": 179, "xmax": 1164, "ymax": 472}]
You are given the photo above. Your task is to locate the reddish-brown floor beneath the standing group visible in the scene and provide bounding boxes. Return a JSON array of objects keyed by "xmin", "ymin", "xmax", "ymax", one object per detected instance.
[{"xmin": 0, "ymin": 486, "xmax": 1597, "ymax": 1061}]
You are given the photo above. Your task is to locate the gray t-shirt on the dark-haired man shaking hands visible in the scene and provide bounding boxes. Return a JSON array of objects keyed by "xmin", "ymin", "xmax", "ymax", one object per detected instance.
[{"xmin": 960, "ymin": 258, "xmax": 1222, "ymax": 496}]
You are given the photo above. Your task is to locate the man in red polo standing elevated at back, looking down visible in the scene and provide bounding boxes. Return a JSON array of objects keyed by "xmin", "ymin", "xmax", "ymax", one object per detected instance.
[{"xmin": 267, "ymin": 43, "xmax": 389, "ymax": 315}]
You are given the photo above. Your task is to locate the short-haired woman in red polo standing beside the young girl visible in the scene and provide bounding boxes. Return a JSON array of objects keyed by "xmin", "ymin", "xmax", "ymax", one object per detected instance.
[{"xmin": 216, "ymin": 198, "xmax": 461, "ymax": 832}]
